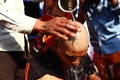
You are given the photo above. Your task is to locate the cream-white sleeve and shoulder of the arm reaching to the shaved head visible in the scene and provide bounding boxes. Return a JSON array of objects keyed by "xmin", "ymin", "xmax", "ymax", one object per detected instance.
[{"xmin": 0, "ymin": 0, "xmax": 37, "ymax": 33}]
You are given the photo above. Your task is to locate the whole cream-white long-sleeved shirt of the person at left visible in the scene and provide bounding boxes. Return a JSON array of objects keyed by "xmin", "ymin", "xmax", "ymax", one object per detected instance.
[{"xmin": 0, "ymin": 0, "xmax": 36, "ymax": 51}]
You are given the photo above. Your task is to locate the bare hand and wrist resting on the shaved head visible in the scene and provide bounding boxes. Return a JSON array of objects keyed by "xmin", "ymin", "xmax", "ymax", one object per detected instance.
[{"xmin": 34, "ymin": 17, "xmax": 79, "ymax": 40}]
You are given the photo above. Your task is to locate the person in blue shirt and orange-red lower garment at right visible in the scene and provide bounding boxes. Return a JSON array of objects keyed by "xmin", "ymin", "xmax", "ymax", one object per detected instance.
[{"xmin": 78, "ymin": 0, "xmax": 120, "ymax": 80}]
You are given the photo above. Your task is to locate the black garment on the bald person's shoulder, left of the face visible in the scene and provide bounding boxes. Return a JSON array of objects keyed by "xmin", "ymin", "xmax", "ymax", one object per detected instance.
[{"xmin": 25, "ymin": 50, "xmax": 64, "ymax": 80}]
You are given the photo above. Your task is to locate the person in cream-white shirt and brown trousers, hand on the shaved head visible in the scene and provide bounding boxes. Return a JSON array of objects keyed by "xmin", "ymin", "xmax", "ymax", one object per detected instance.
[{"xmin": 0, "ymin": 0, "xmax": 78, "ymax": 80}]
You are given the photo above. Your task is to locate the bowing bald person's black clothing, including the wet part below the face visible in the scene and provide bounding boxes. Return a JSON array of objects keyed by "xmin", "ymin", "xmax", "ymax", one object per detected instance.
[{"xmin": 25, "ymin": 50, "xmax": 96, "ymax": 80}]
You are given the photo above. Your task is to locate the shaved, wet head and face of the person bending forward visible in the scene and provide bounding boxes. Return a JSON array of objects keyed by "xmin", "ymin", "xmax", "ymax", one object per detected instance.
[{"xmin": 52, "ymin": 21, "xmax": 89, "ymax": 66}]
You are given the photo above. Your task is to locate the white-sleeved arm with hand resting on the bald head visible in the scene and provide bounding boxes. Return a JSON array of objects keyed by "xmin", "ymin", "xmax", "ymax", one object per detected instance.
[{"xmin": 0, "ymin": 0, "xmax": 79, "ymax": 40}]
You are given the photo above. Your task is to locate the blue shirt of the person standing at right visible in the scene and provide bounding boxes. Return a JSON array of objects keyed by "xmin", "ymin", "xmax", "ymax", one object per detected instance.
[{"xmin": 86, "ymin": 0, "xmax": 120, "ymax": 54}]
